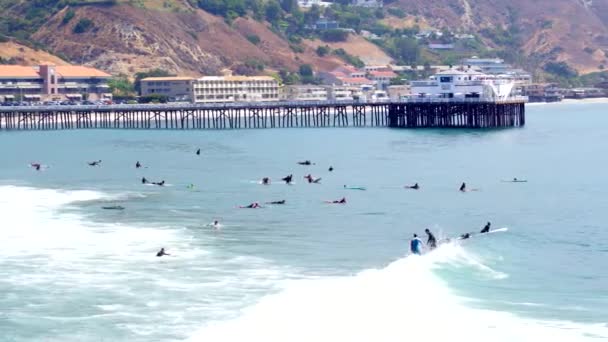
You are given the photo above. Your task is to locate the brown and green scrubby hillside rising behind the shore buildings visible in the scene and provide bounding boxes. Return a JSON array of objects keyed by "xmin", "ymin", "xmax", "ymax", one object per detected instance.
[{"xmin": 0, "ymin": 0, "xmax": 608, "ymax": 81}]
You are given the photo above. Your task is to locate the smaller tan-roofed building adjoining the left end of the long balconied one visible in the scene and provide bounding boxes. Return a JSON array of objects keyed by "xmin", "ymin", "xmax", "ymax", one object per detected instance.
[{"xmin": 140, "ymin": 77, "xmax": 195, "ymax": 102}]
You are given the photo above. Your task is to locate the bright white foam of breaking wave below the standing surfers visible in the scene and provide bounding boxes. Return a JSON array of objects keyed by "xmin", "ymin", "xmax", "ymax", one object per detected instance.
[{"xmin": 189, "ymin": 244, "xmax": 608, "ymax": 342}]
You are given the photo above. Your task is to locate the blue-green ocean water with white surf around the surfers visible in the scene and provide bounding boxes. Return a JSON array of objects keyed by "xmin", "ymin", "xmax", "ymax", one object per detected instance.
[{"xmin": 0, "ymin": 103, "xmax": 608, "ymax": 342}]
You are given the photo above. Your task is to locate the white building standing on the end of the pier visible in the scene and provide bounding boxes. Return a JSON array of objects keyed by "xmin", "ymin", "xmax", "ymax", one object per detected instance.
[{"xmin": 410, "ymin": 68, "xmax": 515, "ymax": 100}]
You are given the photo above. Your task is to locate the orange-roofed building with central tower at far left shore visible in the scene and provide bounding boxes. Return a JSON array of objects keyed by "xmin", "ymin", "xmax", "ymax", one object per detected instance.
[{"xmin": 0, "ymin": 64, "xmax": 112, "ymax": 102}]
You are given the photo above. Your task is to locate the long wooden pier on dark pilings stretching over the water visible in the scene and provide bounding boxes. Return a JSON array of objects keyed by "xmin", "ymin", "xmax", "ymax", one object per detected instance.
[{"xmin": 0, "ymin": 98, "xmax": 525, "ymax": 130}]
